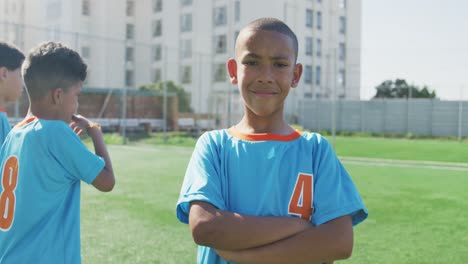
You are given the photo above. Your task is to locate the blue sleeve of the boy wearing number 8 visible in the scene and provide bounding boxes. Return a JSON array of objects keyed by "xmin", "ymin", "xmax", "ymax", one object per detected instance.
[{"xmin": 49, "ymin": 123, "xmax": 105, "ymax": 184}]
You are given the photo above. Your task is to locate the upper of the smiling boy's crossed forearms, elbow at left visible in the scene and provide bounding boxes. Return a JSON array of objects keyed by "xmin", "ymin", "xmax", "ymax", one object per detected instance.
[{"xmin": 189, "ymin": 201, "xmax": 311, "ymax": 251}]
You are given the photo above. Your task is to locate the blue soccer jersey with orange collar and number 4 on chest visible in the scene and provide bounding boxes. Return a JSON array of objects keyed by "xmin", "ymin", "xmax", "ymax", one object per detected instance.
[{"xmin": 176, "ymin": 128, "xmax": 367, "ymax": 264}]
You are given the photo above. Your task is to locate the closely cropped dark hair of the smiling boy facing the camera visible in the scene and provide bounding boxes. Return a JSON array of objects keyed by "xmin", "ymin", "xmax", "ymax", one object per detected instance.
[{"xmin": 239, "ymin": 17, "xmax": 299, "ymax": 60}]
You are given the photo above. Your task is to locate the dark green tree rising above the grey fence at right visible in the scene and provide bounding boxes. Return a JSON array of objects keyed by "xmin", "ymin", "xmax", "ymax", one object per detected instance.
[{"xmin": 374, "ymin": 79, "xmax": 436, "ymax": 98}]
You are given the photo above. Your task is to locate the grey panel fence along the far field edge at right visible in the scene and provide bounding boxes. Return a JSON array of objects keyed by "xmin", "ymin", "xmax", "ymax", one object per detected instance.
[{"xmin": 297, "ymin": 99, "xmax": 468, "ymax": 138}]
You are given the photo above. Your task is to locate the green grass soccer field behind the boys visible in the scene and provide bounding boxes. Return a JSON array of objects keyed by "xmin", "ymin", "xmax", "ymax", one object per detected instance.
[{"xmin": 81, "ymin": 137, "xmax": 468, "ymax": 264}]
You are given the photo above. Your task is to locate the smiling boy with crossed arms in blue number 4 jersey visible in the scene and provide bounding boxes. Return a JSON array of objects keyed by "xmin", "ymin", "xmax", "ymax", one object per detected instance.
[{"xmin": 176, "ymin": 18, "xmax": 367, "ymax": 264}]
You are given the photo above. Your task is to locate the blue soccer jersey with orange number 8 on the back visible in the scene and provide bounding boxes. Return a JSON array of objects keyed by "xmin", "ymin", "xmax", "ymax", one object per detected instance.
[{"xmin": 0, "ymin": 118, "xmax": 105, "ymax": 263}]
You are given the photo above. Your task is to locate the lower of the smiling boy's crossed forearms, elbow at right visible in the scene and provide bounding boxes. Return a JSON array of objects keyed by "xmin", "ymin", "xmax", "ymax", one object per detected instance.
[{"xmin": 216, "ymin": 216, "xmax": 353, "ymax": 264}]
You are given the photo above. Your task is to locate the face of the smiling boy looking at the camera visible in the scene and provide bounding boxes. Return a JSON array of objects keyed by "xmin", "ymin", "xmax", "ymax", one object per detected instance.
[{"xmin": 228, "ymin": 30, "xmax": 302, "ymax": 117}]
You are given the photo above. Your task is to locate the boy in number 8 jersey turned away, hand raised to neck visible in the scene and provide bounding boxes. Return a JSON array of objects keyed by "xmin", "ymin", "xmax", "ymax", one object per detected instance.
[{"xmin": 0, "ymin": 42, "xmax": 115, "ymax": 263}]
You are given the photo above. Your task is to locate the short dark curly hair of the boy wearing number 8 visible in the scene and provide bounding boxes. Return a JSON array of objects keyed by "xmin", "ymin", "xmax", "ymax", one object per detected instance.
[{"xmin": 23, "ymin": 42, "xmax": 87, "ymax": 100}]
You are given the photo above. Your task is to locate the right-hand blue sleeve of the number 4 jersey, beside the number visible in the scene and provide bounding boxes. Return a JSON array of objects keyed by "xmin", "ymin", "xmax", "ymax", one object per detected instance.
[{"xmin": 312, "ymin": 136, "xmax": 368, "ymax": 225}]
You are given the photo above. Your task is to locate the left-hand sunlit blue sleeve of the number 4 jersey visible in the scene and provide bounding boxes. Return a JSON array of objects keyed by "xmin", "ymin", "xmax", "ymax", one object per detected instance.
[{"xmin": 176, "ymin": 133, "xmax": 226, "ymax": 223}]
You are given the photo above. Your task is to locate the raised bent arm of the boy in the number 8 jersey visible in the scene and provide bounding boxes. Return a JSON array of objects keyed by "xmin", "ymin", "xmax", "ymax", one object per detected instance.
[{"xmin": 73, "ymin": 115, "xmax": 115, "ymax": 192}]
